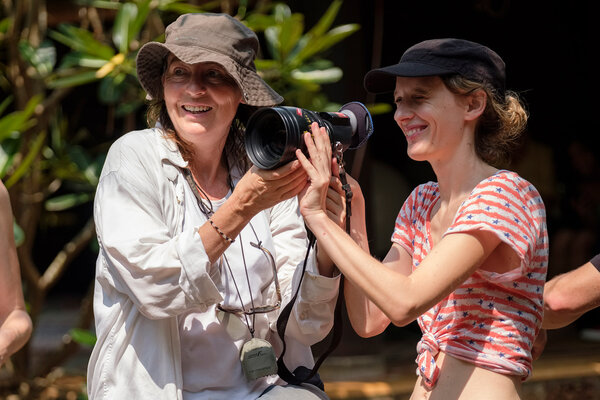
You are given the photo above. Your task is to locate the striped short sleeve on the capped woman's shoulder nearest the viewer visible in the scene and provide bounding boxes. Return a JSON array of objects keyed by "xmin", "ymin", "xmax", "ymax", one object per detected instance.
[{"xmin": 446, "ymin": 171, "xmax": 545, "ymax": 278}]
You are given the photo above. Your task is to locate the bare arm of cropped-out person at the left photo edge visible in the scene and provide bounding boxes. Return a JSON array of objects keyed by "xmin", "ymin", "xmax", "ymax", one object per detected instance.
[{"xmin": 0, "ymin": 181, "xmax": 32, "ymax": 366}]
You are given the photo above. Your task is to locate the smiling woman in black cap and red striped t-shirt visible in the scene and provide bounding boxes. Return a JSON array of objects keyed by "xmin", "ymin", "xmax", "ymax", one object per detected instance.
[{"xmin": 297, "ymin": 39, "xmax": 548, "ymax": 400}]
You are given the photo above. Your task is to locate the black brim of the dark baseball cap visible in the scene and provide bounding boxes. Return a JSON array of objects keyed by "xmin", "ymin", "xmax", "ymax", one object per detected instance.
[{"xmin": 364, "ymin": 62, "xmax": 456, "ymax": 93}]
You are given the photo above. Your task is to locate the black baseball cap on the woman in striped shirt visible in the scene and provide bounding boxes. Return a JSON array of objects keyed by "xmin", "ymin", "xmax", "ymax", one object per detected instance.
[{"xmin": 364, "ymin": 38, "xmax": 506, "ymax": 96}]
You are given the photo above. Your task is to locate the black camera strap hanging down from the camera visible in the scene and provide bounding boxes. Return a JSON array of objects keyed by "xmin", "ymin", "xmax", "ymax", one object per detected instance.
[{"xmin": 277, "ymin": 142, "xmax": 352, "ymax": 391}]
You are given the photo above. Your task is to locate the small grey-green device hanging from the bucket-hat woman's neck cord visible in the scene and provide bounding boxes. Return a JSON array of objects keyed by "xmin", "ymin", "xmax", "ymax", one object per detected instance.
[{"xmin": 240, "ymin": 338, "xmax": 277, "ymax": 381}]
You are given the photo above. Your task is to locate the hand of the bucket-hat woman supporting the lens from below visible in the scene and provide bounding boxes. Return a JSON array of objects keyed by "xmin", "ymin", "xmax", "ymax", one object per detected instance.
[{"xmin": 232, "ymin": 160, "xmax": 307, "ymax": 215}]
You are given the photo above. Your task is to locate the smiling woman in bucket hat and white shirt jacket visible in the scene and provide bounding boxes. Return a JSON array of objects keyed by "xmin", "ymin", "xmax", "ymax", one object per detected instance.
[{"xmin": 88, "ymin": 13, "xmax": 339, "ymax": 400}]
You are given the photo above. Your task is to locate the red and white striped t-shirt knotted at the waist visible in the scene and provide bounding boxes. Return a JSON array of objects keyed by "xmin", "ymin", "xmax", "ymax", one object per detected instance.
[{"xmin": 392, "ymin": 170, "xmax": 548, "ymax": 386}]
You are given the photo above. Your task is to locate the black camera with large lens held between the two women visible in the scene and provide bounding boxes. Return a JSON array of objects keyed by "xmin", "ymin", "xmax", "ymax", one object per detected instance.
[{"xmin": 245, "ymin": 102, "xmax": 373, "ymax": 169}]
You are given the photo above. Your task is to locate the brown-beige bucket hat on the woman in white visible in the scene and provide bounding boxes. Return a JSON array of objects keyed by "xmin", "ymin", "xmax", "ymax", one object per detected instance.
[{"xmin": 136, "ymin": 13, "xmax": 283, "ymax": 107}]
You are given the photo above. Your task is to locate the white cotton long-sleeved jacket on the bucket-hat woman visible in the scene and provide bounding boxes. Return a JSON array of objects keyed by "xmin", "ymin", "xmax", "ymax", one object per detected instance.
[{"xmin": 87, "ymin": 128, "xmax": 339, "ymax": 400}]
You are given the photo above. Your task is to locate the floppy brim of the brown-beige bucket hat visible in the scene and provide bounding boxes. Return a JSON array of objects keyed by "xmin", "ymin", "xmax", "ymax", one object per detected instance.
[{"xmin": 136, "ymin": 42, "xmax": 283, "ymax": 107}]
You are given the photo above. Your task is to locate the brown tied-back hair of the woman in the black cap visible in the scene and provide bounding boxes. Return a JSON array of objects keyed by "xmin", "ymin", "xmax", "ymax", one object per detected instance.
[{"xmin": 441, "ymin": 75, "xmax": 529, "ymax": 167}]
